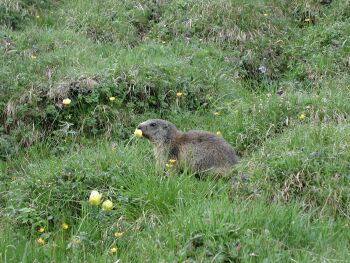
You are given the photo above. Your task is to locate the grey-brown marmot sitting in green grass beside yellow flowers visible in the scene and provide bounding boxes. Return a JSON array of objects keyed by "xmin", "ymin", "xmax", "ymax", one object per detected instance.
[{"xmin": 137, "ymin": 119, "xmax": 238, "ymax": 174}]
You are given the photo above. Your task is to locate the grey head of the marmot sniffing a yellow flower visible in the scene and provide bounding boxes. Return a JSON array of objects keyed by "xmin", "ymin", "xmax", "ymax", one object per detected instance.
[{"xmin": 137, "ymin": 119, "xmax": 177, "ymax": 144}]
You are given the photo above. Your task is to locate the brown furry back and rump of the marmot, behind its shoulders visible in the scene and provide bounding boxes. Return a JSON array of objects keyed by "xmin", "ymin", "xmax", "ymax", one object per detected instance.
[{"xmin": 175, "ymin": 131, "xmax": 237, "ymax": 173}]
